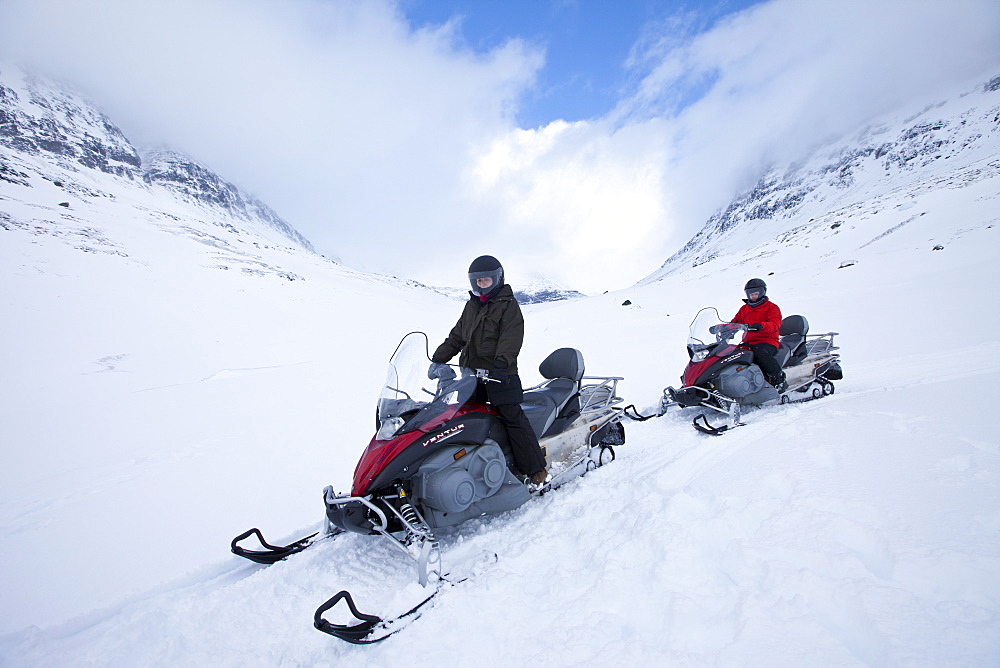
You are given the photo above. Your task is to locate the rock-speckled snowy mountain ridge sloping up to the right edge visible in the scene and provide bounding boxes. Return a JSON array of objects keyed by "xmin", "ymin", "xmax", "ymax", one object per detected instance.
[{"xmin": 637, "ymin": 76, "xmax": 1000, "ymax": 285}]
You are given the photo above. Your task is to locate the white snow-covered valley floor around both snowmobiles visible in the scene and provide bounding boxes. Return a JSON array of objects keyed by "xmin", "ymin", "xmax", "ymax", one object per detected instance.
[{"xmin": 0, "ymin": 77, "xmax": 1000, "ymax": 666}]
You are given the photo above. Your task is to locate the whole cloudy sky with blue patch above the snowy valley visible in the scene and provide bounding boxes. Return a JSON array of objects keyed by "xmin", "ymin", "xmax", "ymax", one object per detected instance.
[{"xmin": 0, "ymin": 0, "xmax": 1000, "ymax": 293}]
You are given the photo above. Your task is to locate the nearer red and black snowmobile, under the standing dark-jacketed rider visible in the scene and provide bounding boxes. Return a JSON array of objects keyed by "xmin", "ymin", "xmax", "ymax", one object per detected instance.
[{"xmin": 232, "ymin": 332, "xmax": 625, "ymax": 585}]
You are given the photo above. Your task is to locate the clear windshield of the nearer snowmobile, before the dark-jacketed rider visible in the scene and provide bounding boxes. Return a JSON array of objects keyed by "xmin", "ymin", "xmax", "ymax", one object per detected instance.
[{"xmin": 375, "ymin": 332, "xmax": 478, "ymax": 441}]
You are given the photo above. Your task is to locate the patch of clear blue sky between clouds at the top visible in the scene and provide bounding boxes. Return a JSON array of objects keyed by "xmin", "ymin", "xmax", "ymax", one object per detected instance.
[{"xmin": 401, "ymin": 0, "xmax": 759, "ymax": 128}]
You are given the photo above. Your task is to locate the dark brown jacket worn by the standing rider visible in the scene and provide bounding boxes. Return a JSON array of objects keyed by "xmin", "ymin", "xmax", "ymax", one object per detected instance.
[{"xmin": 431, "ymin": 285, "xmax": 524, "ymax": 375}]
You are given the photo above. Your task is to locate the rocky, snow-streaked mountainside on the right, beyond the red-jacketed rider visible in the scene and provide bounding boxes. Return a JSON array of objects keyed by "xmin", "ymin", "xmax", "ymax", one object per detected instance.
[{"xmin": 640, "ymin": 77, "xmax": 1000, "ymax": 284}]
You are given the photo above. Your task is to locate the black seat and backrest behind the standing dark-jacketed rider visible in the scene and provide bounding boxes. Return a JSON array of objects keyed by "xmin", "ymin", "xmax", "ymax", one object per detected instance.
[{"xmin": 521, "ymin": 348, "xmax": 584, "ymax": 438}]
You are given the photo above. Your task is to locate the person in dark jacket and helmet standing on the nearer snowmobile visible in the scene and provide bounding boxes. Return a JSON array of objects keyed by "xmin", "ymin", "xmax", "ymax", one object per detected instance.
[{"xmin": 428, "ymin": 255, "xmax": 547, "ymax": 485}]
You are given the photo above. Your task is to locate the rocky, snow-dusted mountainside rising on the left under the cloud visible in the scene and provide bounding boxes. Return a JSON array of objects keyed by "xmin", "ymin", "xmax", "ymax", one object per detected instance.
[{"xmin": 0, "ymin": 65, "xmax": 313, "ymax": 258}]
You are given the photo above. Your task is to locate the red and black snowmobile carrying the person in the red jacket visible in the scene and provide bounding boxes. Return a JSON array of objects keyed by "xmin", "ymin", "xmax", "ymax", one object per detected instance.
[{"xmin": 660, "ymin": 307, "xmax": 844, "ymax": 436}]
